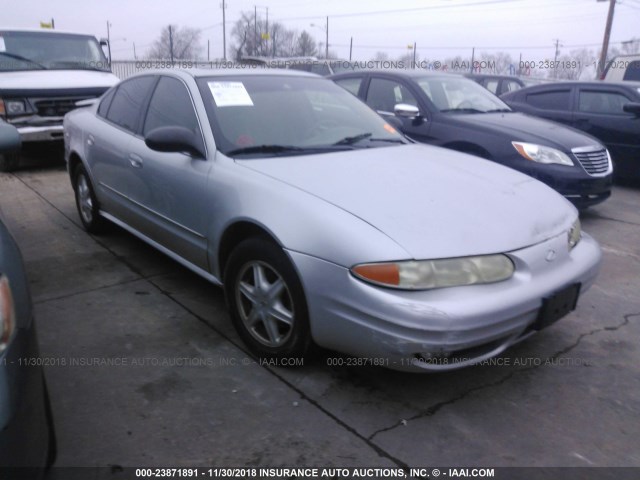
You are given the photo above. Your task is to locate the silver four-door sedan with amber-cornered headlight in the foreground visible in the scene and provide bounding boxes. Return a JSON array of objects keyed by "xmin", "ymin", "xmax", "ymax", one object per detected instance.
[{"xmin": 64, "ymin": 70, "xmax": 601, "ymax": 371}]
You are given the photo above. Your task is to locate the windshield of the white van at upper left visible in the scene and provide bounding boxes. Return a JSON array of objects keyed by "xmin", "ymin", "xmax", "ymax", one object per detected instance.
[{"xmin": 0, "ymin": 31, "xmax": 109, "ymax": 72}]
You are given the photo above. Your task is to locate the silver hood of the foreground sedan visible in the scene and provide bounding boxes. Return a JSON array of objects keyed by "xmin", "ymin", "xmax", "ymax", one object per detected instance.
[{"xmin": 237, "ymin": 145, "xmax": 577, "ymax": 259}]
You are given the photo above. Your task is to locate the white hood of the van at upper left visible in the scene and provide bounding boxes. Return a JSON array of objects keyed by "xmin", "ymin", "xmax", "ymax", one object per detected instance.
[{"xmin": 0, "ymin": 70, "xmax": 119, "ymax": 91}]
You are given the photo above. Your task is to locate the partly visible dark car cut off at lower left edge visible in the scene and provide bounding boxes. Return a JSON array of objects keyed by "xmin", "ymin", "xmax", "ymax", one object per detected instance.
[{"xmin": 0, "ymin": 130, "xmax": 56, "ymax": 468}]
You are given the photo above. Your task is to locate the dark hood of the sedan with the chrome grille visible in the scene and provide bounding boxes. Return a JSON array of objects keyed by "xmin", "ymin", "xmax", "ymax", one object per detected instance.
[{"xmin": 446, "ymin": 112, "xmax": 601, "ymax": 151}]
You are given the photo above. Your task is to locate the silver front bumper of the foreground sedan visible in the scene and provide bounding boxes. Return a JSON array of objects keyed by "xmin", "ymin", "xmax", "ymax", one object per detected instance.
[{"xmin": 288, "ymin": 233, "xmax": 602, "ymax": 371}]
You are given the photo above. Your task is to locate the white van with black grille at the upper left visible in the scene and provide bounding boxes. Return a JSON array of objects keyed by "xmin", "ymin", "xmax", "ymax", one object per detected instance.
[{"xmin": 0, "ymin": 27, "xmax": 118, "ymax": 171}]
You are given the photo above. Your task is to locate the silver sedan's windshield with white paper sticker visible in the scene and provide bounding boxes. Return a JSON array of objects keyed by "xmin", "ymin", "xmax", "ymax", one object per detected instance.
[{"xmin": 198, "ymin": 75, "xmax": 407, "ymax": 157}]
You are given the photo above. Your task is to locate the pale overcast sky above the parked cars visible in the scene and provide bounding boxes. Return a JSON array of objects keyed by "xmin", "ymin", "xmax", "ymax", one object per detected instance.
[{"xmin": 0, "ymin": 0, "xmax": 640, "ymax": 60}]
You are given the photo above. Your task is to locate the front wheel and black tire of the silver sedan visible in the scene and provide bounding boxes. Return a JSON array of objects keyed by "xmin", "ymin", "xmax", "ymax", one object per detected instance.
[{"xmin": 224, "ymin": 238, "xmax": 313, "ymax": 359}]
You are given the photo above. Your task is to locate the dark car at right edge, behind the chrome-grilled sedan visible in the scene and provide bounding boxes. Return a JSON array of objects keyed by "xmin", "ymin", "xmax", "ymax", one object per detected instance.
[{"xmin": 502, "ymin": 82, "xmax": 640, "ymax": 180}]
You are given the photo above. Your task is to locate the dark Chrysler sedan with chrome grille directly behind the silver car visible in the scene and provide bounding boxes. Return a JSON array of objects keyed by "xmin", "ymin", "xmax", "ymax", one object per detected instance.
[{"xmin": 330, "ymin": 70, "xmax": 613, "ymax": 208}]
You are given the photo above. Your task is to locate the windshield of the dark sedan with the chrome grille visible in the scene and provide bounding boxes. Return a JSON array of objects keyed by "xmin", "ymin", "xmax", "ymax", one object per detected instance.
[{"xmin": 416, "ymin": 76, "xmax": 511, "ymax": 113}]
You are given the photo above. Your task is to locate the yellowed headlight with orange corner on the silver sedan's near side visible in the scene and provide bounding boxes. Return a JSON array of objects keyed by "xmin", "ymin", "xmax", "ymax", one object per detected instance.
[{"xmin": 351, "ymin": 255, "xmax": 514, "ymax": 290}]
